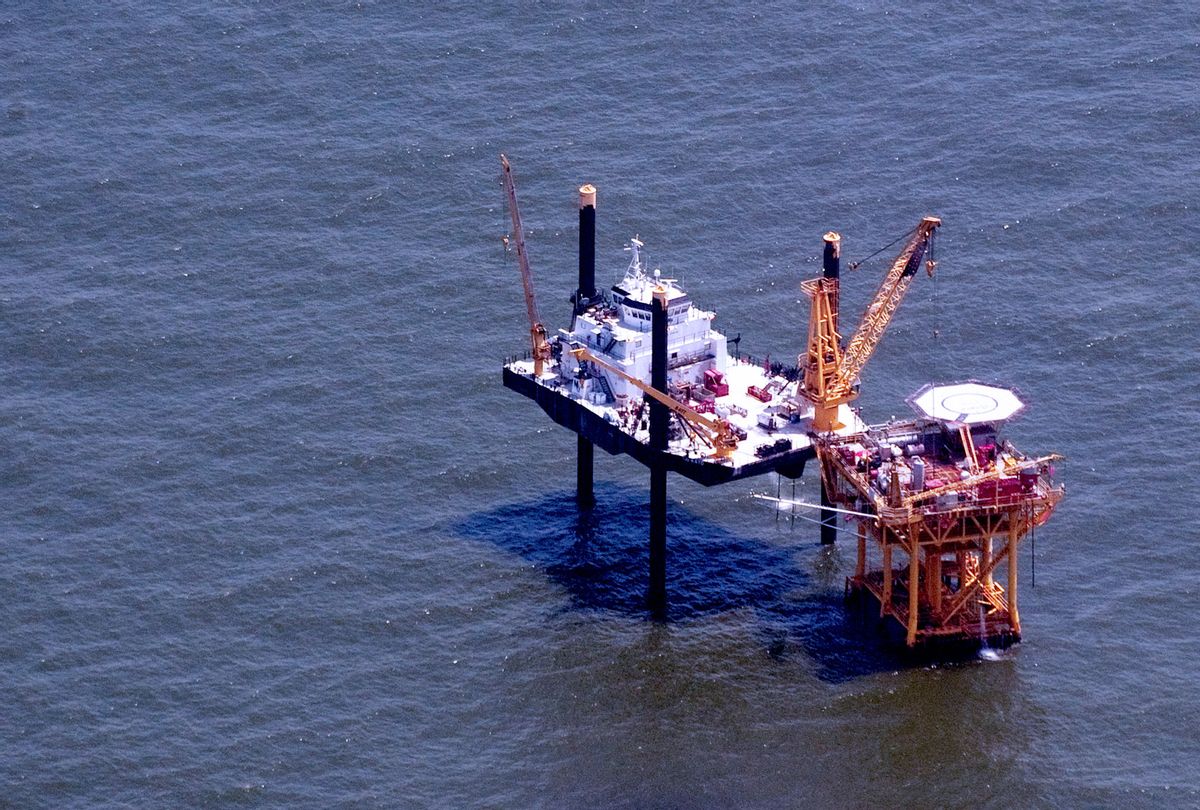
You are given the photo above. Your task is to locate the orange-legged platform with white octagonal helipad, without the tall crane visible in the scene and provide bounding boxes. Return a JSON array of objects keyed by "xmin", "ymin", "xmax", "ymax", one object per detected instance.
[{"xmin": 816, "ymin": 382, "xmax": 1066, "ymax": 647}]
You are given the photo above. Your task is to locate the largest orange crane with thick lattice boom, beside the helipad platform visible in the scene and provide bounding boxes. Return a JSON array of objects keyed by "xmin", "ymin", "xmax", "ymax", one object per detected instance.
[{"xmin": 799, "ymin": 216, "xmax": 942, "ymax": 433}]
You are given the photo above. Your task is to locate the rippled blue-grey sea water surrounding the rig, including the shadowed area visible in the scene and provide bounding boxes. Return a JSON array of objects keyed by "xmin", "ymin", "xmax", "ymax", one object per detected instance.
[{"xmin": 0, "ymin": 1, "xmax": 1200, "ymax": 808}]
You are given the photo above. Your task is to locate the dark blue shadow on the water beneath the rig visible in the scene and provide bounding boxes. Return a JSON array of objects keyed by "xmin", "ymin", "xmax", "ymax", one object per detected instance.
[{"xmin": 457, "ymin": 484, "xmax": 912, "ymax": 682}]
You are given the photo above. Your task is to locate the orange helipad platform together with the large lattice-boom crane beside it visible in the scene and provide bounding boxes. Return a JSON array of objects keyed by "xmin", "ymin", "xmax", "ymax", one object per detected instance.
[{"xmin": 799, "ymin": 223, "xmax": 1064, "ymax": 648}]
